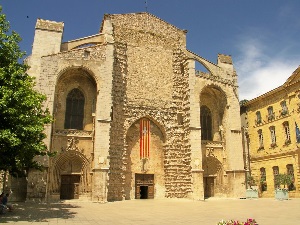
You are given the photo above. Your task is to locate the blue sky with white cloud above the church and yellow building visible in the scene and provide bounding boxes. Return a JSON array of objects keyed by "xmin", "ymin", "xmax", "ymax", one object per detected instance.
[{"xmin": 0, "ymin": 0, "xmax": 300, "ymax": 100}]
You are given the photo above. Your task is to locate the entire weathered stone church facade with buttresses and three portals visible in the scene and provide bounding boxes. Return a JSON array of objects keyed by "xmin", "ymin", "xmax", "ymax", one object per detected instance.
[{"xmin": 16, "ymin": 13, "xmax": 245, "ymax": 201}]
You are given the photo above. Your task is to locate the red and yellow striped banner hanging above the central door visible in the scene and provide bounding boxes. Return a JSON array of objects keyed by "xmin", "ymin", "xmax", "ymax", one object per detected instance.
[{"xmin": 140, "ymin": 119, "xmax": 150, "ymax": 159}]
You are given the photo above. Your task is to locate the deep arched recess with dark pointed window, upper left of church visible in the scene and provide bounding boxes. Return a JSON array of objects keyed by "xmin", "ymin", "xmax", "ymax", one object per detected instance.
[{"xmin": 53, "ymin": 67, "xmax": 97, "ymax": 130}]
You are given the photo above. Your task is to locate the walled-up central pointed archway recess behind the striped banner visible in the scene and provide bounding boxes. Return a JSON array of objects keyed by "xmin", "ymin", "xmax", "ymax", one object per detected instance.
[{"xmin": 124, "ymin": 118, "xmax": 165, "ymax": 199}]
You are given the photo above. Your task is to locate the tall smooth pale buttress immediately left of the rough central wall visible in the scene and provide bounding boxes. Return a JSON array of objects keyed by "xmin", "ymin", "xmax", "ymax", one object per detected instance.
[{"xmin": 92, "ymin": 37, "xmax": 114, "ymax": 202}]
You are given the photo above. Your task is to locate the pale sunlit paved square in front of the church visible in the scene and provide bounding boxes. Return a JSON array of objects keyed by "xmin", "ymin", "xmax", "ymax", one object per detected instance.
[{"xmin": 0, "ymin": 198, "xmax": 300, "ymax": 225}]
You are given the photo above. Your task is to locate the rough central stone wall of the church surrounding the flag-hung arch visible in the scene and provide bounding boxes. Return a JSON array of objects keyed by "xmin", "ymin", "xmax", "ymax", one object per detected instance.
[{"xmin": 108, "ymin": 14, "xmax": 191, "ymax": 199}]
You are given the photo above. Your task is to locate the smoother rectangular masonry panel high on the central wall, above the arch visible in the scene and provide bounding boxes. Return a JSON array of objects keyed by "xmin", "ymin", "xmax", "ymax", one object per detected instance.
[{"xmin": 127, "ymin": 46, "xmax": 174, "ymax": 108}]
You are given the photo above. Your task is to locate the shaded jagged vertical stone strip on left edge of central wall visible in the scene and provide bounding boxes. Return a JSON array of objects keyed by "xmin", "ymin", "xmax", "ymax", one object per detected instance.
[{"xmin": 107, "ymin": 43, "xmax": 127, "ymax": 201}]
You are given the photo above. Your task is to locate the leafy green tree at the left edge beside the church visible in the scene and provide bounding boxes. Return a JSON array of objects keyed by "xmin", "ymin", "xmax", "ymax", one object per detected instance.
[{"xmin": 0, "ymin": 6, "xmax": 52, "ymax": 174}]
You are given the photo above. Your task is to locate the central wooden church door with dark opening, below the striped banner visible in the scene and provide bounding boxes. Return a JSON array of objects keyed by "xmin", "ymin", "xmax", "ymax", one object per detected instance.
[{"xmin": 135, "ymin": 174, "xmax": 154, "ymax": 199}]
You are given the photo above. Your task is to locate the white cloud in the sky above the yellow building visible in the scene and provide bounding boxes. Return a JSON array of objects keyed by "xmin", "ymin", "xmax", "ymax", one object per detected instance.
[{"xmin": 235, "ymin": 38, "xmax": 300, "ymax": 100}]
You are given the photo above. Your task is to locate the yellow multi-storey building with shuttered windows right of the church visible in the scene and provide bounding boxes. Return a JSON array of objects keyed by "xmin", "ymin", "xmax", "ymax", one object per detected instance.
[{"xmin": 242, "ymin": 67, "xmax": 300, "ymax": 197}]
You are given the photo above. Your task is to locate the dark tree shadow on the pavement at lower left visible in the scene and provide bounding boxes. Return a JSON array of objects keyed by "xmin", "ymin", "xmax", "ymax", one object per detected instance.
[{"xmin": 0, "ymin": 202, "xmax": 79, "ymax": 223}]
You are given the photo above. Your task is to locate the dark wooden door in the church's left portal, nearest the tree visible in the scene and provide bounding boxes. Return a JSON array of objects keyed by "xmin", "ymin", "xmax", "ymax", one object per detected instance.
[{"xmin": 60, "ymin": 175, "xmax": 80, "ymax": 199}]
